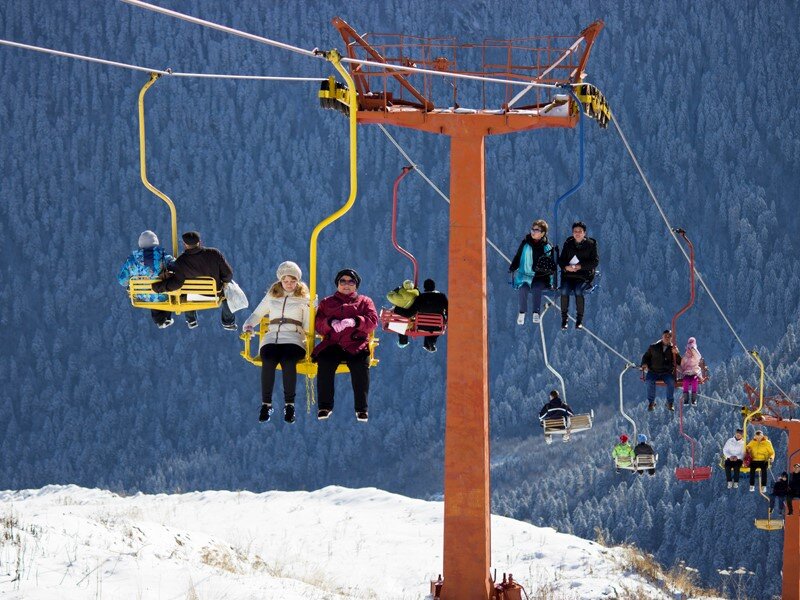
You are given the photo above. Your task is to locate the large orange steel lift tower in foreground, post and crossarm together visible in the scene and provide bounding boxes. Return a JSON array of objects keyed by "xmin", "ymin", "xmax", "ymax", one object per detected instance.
[{"xmin": 328, "ymin": 17, "xmax": 604, "ymax": 600}]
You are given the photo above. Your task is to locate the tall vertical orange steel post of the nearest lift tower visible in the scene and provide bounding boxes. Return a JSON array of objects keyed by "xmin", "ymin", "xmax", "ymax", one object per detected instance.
[{"xmin": 441, "ymin": 132, "xmax": 492, "ymax": 600}]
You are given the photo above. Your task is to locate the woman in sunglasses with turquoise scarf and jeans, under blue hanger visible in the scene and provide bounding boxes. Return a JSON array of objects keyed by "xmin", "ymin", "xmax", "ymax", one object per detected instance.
[{"xmin": 508, "ymin": 219, "xmax": 556, "ymax": 325}]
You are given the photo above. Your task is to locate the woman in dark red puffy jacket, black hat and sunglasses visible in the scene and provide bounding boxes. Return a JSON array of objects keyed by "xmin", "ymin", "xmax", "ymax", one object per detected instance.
[{"xmin": 311, "ymin": 269, "xmax": 378, "ymax": 422}]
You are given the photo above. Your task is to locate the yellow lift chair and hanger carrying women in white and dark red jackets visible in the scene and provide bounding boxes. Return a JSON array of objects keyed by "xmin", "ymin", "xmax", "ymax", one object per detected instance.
[{"xmin": 239, "ymin": 50, "xmax": 379, "ymax": 379}]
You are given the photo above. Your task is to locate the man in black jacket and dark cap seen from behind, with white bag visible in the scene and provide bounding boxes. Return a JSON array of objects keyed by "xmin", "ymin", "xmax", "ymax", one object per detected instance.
[{"xmin": 153, "ymin": 231, "xmax": 236, "ymax": 331}]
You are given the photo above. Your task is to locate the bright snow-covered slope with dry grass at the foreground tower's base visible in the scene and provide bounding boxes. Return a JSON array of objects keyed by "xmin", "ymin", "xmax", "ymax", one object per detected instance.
[{"xmin": 0, "ymin": 486, "xmax": 688, "ymax": 600}]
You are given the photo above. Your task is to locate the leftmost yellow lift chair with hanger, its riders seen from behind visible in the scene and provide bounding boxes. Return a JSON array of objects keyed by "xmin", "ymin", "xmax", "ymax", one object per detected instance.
[{"xmin": 128, "ymin": 73, "xmax": 225, "ymax": 314}]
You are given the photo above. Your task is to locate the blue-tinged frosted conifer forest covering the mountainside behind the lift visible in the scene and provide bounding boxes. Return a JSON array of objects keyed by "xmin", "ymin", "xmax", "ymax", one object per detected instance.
[{"xmin": 0, "ymin": 0, "xmax": 800, "ymax": 598}]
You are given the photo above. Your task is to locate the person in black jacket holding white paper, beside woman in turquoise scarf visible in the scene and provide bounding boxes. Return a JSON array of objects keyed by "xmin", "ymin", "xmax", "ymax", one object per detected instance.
[{"xmin": 558, "ymin": 221, "xmax": 600, "ymax": 329}]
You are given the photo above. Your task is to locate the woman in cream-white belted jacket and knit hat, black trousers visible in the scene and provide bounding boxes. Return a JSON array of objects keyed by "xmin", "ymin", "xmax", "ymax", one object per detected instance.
[{"xmin": 244, "ymin": 261, "xmax": 309, "ymax": 423}]
